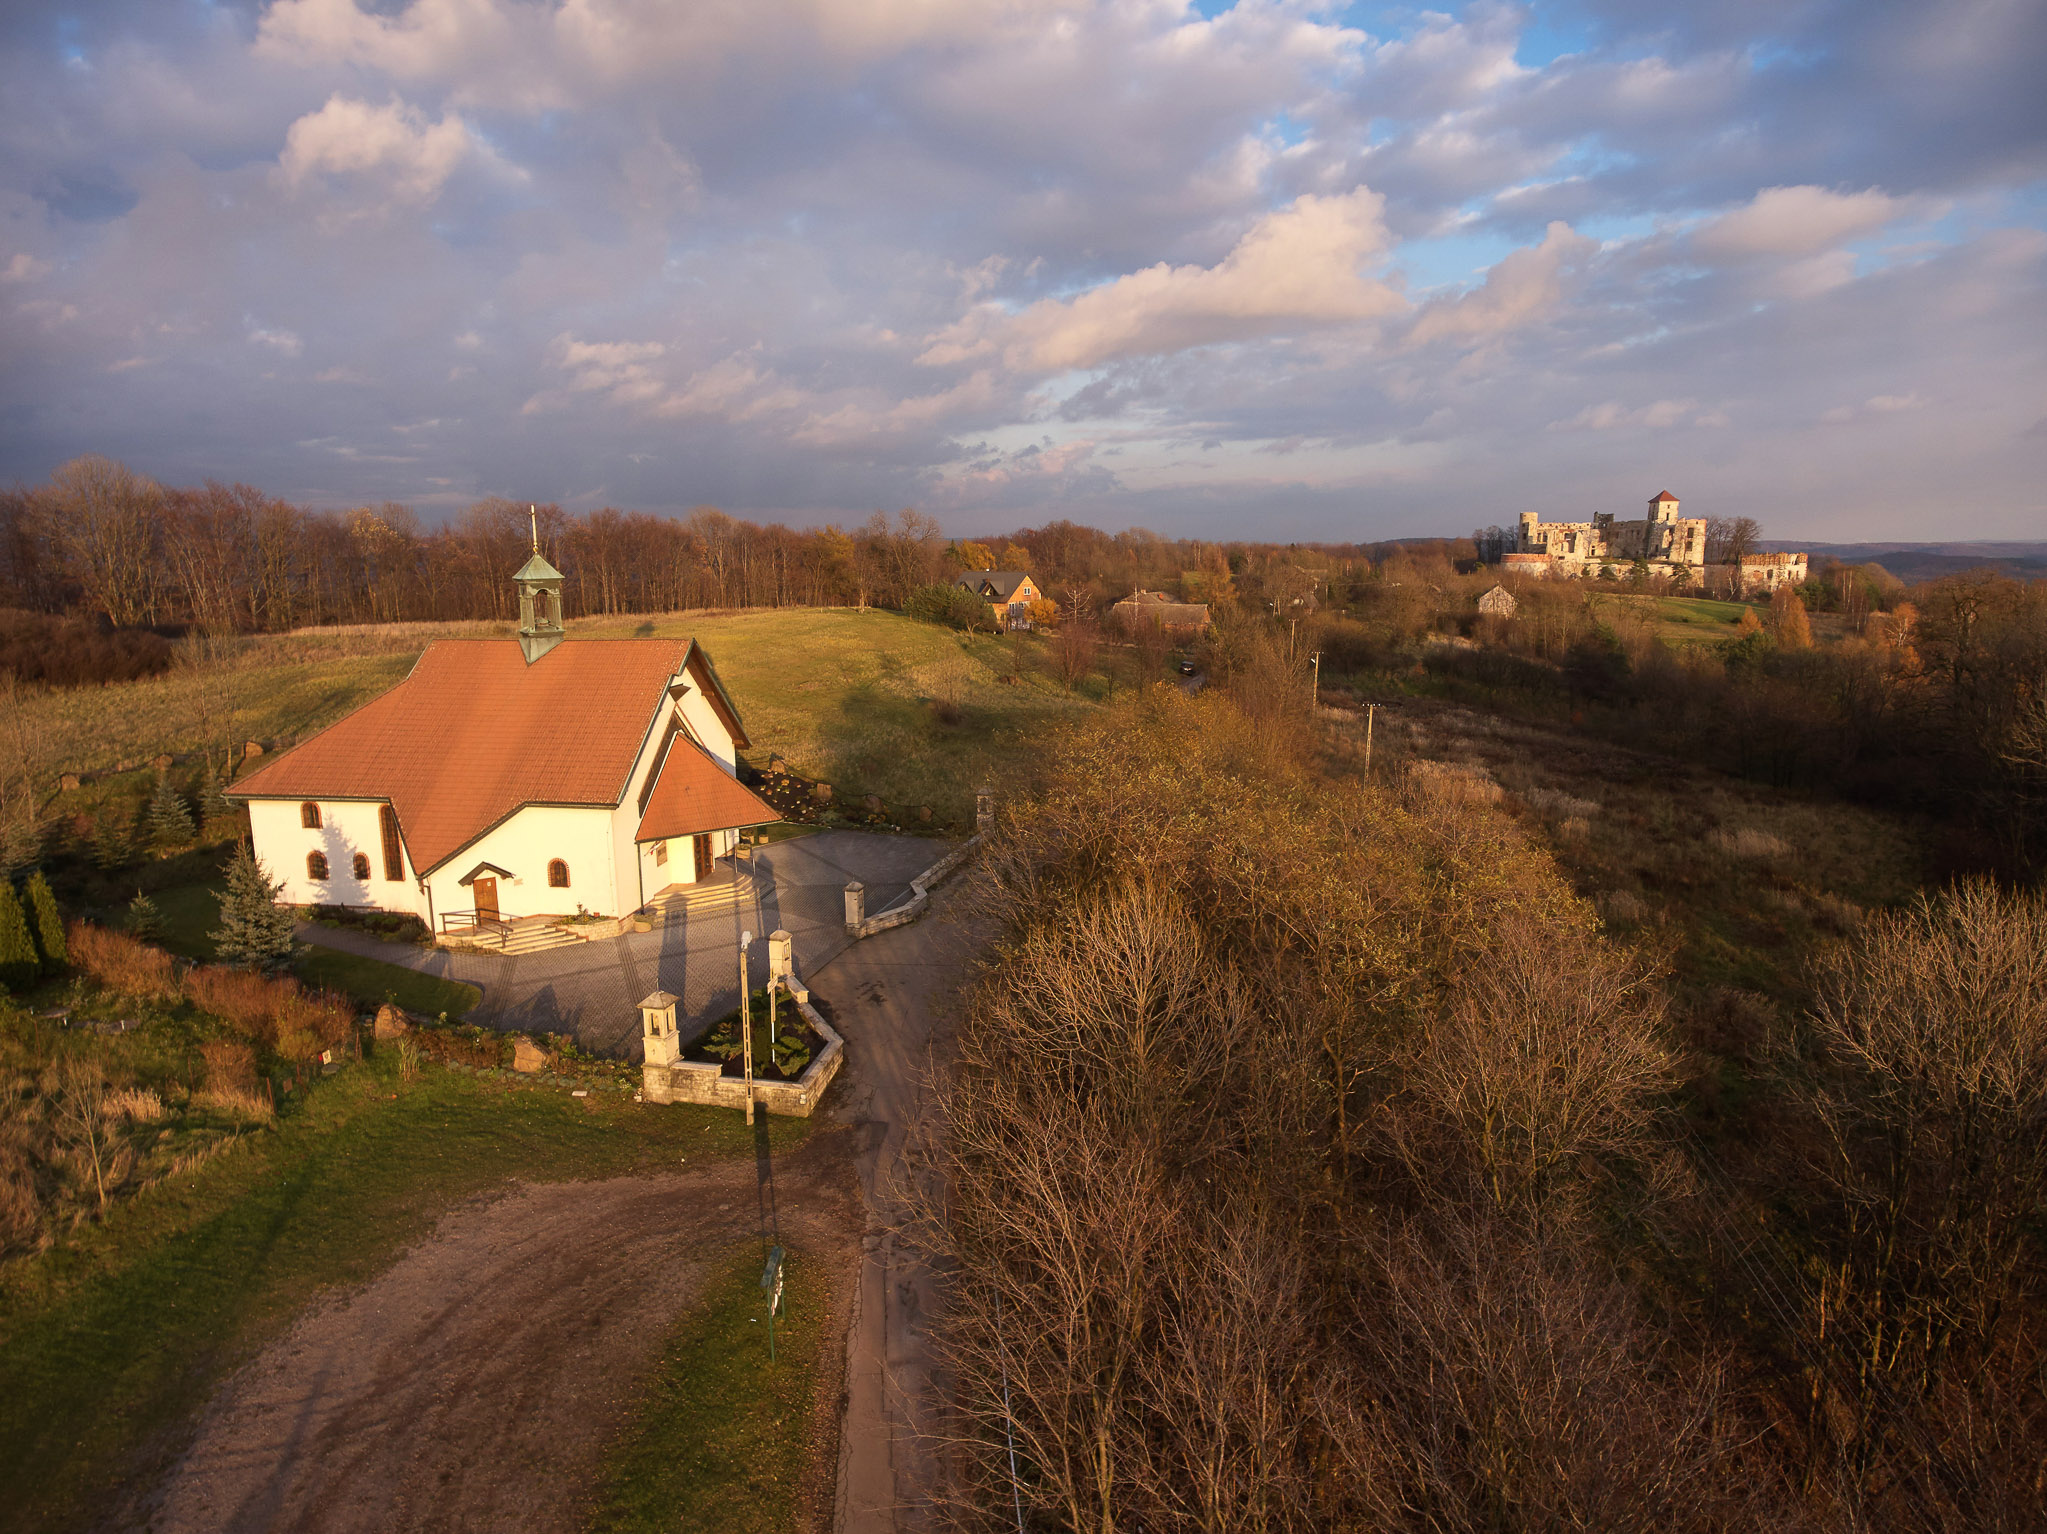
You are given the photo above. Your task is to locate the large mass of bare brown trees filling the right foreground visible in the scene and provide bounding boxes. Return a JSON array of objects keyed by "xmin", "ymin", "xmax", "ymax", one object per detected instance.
[{"xmin": 923, "ymin": 684, "xmax": 2047, "ymax": 1534}]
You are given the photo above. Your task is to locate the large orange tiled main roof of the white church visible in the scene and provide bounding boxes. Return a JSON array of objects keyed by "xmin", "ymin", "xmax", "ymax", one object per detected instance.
[{"xmin": 233, "ymin": 639, "xmax": 695, "ymax": 872}]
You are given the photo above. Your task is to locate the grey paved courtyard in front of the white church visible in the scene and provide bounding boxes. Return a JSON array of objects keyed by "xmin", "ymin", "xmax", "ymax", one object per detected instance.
[{"xmin": 299, "ymin": 832, "xmax": 954, "ymax": 1059}]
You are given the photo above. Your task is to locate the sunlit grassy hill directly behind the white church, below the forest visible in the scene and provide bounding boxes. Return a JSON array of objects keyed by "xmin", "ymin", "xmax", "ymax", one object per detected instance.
[{"xmin": 7, "ymin": 608, "xmax": 1132, "ymax": 821}]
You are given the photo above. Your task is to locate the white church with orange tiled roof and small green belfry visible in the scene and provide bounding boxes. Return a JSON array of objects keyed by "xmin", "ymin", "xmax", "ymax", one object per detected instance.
[{"xmin": 231, "ymin": 545, "xmax": 778, "ymax": 932}]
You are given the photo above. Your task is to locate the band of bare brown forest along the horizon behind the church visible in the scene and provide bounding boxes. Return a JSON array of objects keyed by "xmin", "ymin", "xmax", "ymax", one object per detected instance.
[{"xmin": 0, "ymin": 457, "xmax": 1369, "ymax": 633}]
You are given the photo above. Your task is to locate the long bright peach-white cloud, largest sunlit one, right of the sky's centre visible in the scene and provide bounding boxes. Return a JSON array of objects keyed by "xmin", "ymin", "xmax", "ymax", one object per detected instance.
[{"xmin": 917, "ymin": 186, "xmax": 1404, "ymax": 373}]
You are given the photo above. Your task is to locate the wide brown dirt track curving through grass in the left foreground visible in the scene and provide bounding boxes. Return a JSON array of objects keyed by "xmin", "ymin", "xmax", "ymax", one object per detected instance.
[{"xmin": 138, "ymin": 1135, "xmax": 860, "ymax": 1534}]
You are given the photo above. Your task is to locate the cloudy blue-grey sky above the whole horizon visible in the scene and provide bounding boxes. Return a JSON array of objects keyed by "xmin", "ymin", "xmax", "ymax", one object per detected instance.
[{"xmin": 0, "ymin": 0, "xmax": 2047, "ymax": 541}]
